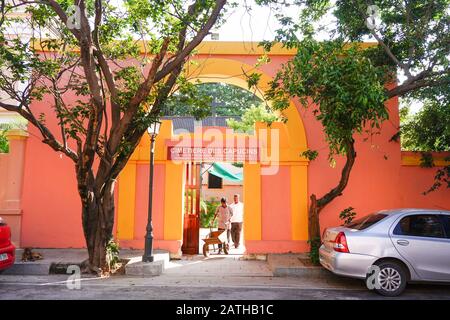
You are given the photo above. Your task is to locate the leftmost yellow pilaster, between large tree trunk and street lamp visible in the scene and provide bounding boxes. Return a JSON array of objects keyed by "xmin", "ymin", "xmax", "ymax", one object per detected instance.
[{"xmin": 117, "ymin": 163, "xmax": 136, "ymax": 240}]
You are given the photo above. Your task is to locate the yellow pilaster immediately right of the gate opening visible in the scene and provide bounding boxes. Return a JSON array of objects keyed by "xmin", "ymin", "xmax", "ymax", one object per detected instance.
[{"xmin": 243, "ymin": 163, "xmax": 262, "ymax": 240}]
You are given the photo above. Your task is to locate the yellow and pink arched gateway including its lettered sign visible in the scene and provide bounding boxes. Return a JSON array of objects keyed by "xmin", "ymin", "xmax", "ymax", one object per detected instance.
[{"xmin": 117, "ymin": 44, "xmax": 308, "ymax": 256}]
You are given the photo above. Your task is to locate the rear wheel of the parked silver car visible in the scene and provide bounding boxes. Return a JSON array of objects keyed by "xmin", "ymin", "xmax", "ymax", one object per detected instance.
[{"xmin": 366, "ymin": 261, "xmax": 407, "ymax": 297}]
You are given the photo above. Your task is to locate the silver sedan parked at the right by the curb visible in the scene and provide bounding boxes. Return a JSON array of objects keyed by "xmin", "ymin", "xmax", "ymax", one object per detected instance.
[{"xmin": 319, "ymin": 209, "xmax": 450, "ymax": 297}]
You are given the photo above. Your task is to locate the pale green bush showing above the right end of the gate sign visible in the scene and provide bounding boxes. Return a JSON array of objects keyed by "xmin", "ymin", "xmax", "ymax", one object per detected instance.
[{"xmin": 227, "ymin": 104, "xmax": 280, "ymax": 133}]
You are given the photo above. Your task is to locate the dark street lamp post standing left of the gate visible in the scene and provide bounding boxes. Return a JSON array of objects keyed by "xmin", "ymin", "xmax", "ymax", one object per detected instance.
[{"xmin": 142, "ymin": 121, "xmax": 161, "ymax": 262}]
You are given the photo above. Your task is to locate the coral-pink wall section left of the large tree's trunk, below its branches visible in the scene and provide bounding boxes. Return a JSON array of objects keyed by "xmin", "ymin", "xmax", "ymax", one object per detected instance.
[{"xmin": 22, "ymin": 123, "xmax": 85, "ymax": 248}]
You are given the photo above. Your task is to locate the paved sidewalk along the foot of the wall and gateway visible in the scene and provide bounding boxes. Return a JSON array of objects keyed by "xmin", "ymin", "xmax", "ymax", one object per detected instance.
[{"xmin": 5, "ymin": 249, "xmax": 334, "ymax": 278}]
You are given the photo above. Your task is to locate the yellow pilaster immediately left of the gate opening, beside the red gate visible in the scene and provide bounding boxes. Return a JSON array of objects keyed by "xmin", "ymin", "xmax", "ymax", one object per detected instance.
[{"xmin": 164, "ymin": 161, "xmax": 185, "ymax": 240}]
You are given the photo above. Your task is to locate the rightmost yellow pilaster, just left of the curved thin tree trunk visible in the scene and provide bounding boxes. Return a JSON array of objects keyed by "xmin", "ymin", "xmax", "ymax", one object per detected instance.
[{"xmin": 291, "ymin": 166, "xmax": 308, "ymax": 240}]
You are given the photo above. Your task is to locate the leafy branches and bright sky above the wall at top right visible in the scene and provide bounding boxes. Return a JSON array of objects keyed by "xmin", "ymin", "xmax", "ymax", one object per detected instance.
[{"xmin": 257, "ymin": 0, "xmax": 450, "ymax": 104}]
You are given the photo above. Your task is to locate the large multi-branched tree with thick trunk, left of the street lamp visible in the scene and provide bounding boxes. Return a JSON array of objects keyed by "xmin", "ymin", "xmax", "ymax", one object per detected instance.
[{"xmin": 0, "ymin": 0, "xmax": 226, "ymax": 272}]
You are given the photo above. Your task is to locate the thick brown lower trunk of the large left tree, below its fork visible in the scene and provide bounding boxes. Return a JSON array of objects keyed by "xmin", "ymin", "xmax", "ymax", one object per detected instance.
[{"xmin": 82, "ymin": 183, "xmax": 115, "ymax": 274}]
